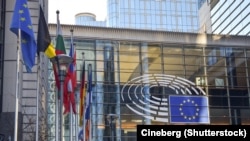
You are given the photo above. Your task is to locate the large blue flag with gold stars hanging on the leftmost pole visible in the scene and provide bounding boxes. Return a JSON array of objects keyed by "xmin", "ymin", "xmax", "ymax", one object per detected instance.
[{"xmin": 10, "ymin": 0, "xmax": 37, "ymax": 72}]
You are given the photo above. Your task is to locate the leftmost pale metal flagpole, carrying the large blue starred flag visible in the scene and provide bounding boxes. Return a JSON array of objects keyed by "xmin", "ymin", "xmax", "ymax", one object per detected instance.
[{"xmin": 14, "ymin": 28, "xmax": 21, "ymax": 141}]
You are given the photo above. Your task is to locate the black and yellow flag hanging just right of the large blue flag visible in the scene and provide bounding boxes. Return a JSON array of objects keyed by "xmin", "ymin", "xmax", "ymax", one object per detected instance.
[{"xmin": 37, "ymin": 6, "xmax": 56, "ymax": 58}]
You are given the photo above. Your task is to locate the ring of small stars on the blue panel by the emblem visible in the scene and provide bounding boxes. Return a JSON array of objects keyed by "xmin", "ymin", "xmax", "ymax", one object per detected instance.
[{"xmin": 179, "ymin": 99, "xmax": 200, "ymax": 120}]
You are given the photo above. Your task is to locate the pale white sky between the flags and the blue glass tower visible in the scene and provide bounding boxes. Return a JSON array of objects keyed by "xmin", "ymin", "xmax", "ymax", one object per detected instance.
[{"xmin": 48, "ymin": 0, "xmax": 106, "ymax": 24}]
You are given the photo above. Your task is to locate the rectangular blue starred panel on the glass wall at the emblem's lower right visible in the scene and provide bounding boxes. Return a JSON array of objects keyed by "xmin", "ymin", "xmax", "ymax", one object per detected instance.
[{"xmin": 169, "ymin": 95, "xmax": 209, "ymax": 123}]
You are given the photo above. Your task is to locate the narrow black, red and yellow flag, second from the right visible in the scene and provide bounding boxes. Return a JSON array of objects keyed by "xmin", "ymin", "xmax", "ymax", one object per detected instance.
[{"xmin": 79, "ymin": 60, "xmax": 86, "ymax": 126}]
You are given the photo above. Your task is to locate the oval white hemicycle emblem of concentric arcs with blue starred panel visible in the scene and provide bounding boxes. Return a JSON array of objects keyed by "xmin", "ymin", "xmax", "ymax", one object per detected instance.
[{"xmin": 121, "ymin": 74, "xmax": 208, "ymax": 123}]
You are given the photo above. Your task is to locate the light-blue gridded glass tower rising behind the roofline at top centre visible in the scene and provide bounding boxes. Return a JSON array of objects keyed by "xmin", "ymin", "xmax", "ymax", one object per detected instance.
[{"xmin": 107, "ymin": 0, "xmax": 199, "ymax": 32}]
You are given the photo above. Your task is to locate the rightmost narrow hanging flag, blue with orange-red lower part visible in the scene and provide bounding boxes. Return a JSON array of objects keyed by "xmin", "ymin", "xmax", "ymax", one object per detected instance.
[{"xmin": 84, "ymin": 64, "xmax": 92, "ymax": 141}]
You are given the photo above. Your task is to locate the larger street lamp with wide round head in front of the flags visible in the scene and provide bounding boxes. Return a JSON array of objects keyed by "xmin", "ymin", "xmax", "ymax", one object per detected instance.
[{"xmin": 50, "ymin": 54, "xmax": 73, "ymax": 141}]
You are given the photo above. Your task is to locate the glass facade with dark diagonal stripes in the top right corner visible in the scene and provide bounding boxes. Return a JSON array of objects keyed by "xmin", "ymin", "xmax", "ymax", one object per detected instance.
[{"xmin": 211, "ymin": 0, "xmax": 250, "ymax": 36}]
